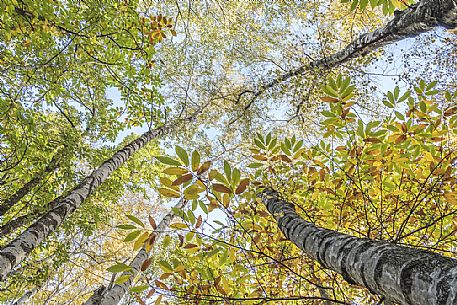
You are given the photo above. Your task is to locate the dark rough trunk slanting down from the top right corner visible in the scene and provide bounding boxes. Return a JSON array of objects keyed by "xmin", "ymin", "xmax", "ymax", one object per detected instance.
[{"xmin": 251, "ymin": 0, "xmax": 457, "ymax": 98}]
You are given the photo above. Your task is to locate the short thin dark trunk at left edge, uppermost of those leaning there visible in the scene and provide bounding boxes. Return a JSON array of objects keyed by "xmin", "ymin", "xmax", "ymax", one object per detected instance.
[{"xmin": 0, "ymin": 153, "xmax": 60, "ymax": 216}]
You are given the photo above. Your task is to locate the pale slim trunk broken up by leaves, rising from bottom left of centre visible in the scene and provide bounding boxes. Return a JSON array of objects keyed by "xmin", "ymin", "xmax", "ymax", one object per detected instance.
[{"xmin": 84, "ymin": 200, "xmax": 186, "ymax": 305}]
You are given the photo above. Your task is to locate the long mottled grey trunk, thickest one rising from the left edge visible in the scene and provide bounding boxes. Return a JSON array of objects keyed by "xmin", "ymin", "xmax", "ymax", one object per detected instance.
[{"xmin": 0, "ymin": 116, "xmax": 194, "ymax": 280}]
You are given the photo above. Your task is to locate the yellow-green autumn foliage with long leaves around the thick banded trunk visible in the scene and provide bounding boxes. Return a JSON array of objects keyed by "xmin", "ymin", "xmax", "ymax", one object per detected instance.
[{"xmin": 147, "ymin": 75, "xmax": 457, "ymax": 304}]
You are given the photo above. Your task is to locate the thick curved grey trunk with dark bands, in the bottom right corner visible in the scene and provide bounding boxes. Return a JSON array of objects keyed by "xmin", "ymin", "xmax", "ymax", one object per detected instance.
[{"xmin": 259, "ymin": 189, "xmax": 457, "ymax": 305}]
